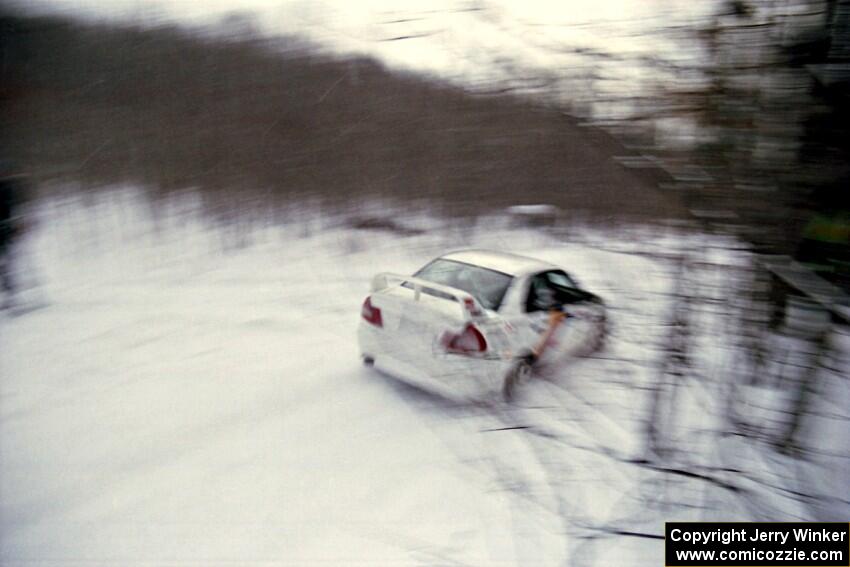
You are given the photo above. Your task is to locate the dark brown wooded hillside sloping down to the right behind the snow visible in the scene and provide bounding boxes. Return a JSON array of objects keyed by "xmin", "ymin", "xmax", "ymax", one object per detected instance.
[{"xmin": 0, "ymin": 12, "xmax": 679, "ymax": 217}]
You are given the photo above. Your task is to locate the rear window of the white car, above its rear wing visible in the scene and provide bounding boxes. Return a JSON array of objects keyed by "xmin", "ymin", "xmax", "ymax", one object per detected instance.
[{"xmin": 414, "ymin": 258, "xmax": 513, "ymax": 311}]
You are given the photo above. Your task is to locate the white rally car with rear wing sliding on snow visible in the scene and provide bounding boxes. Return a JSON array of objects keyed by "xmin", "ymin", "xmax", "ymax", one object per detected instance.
[{"xmin": 358, "ymin": 250, "xmax": 606, "ymax": 398}]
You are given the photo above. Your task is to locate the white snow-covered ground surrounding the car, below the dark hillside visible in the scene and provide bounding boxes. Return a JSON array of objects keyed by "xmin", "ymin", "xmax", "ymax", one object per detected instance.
[{"xmin": 0, "ymin": 189, "xmax": 846, "ymax": 566}]
